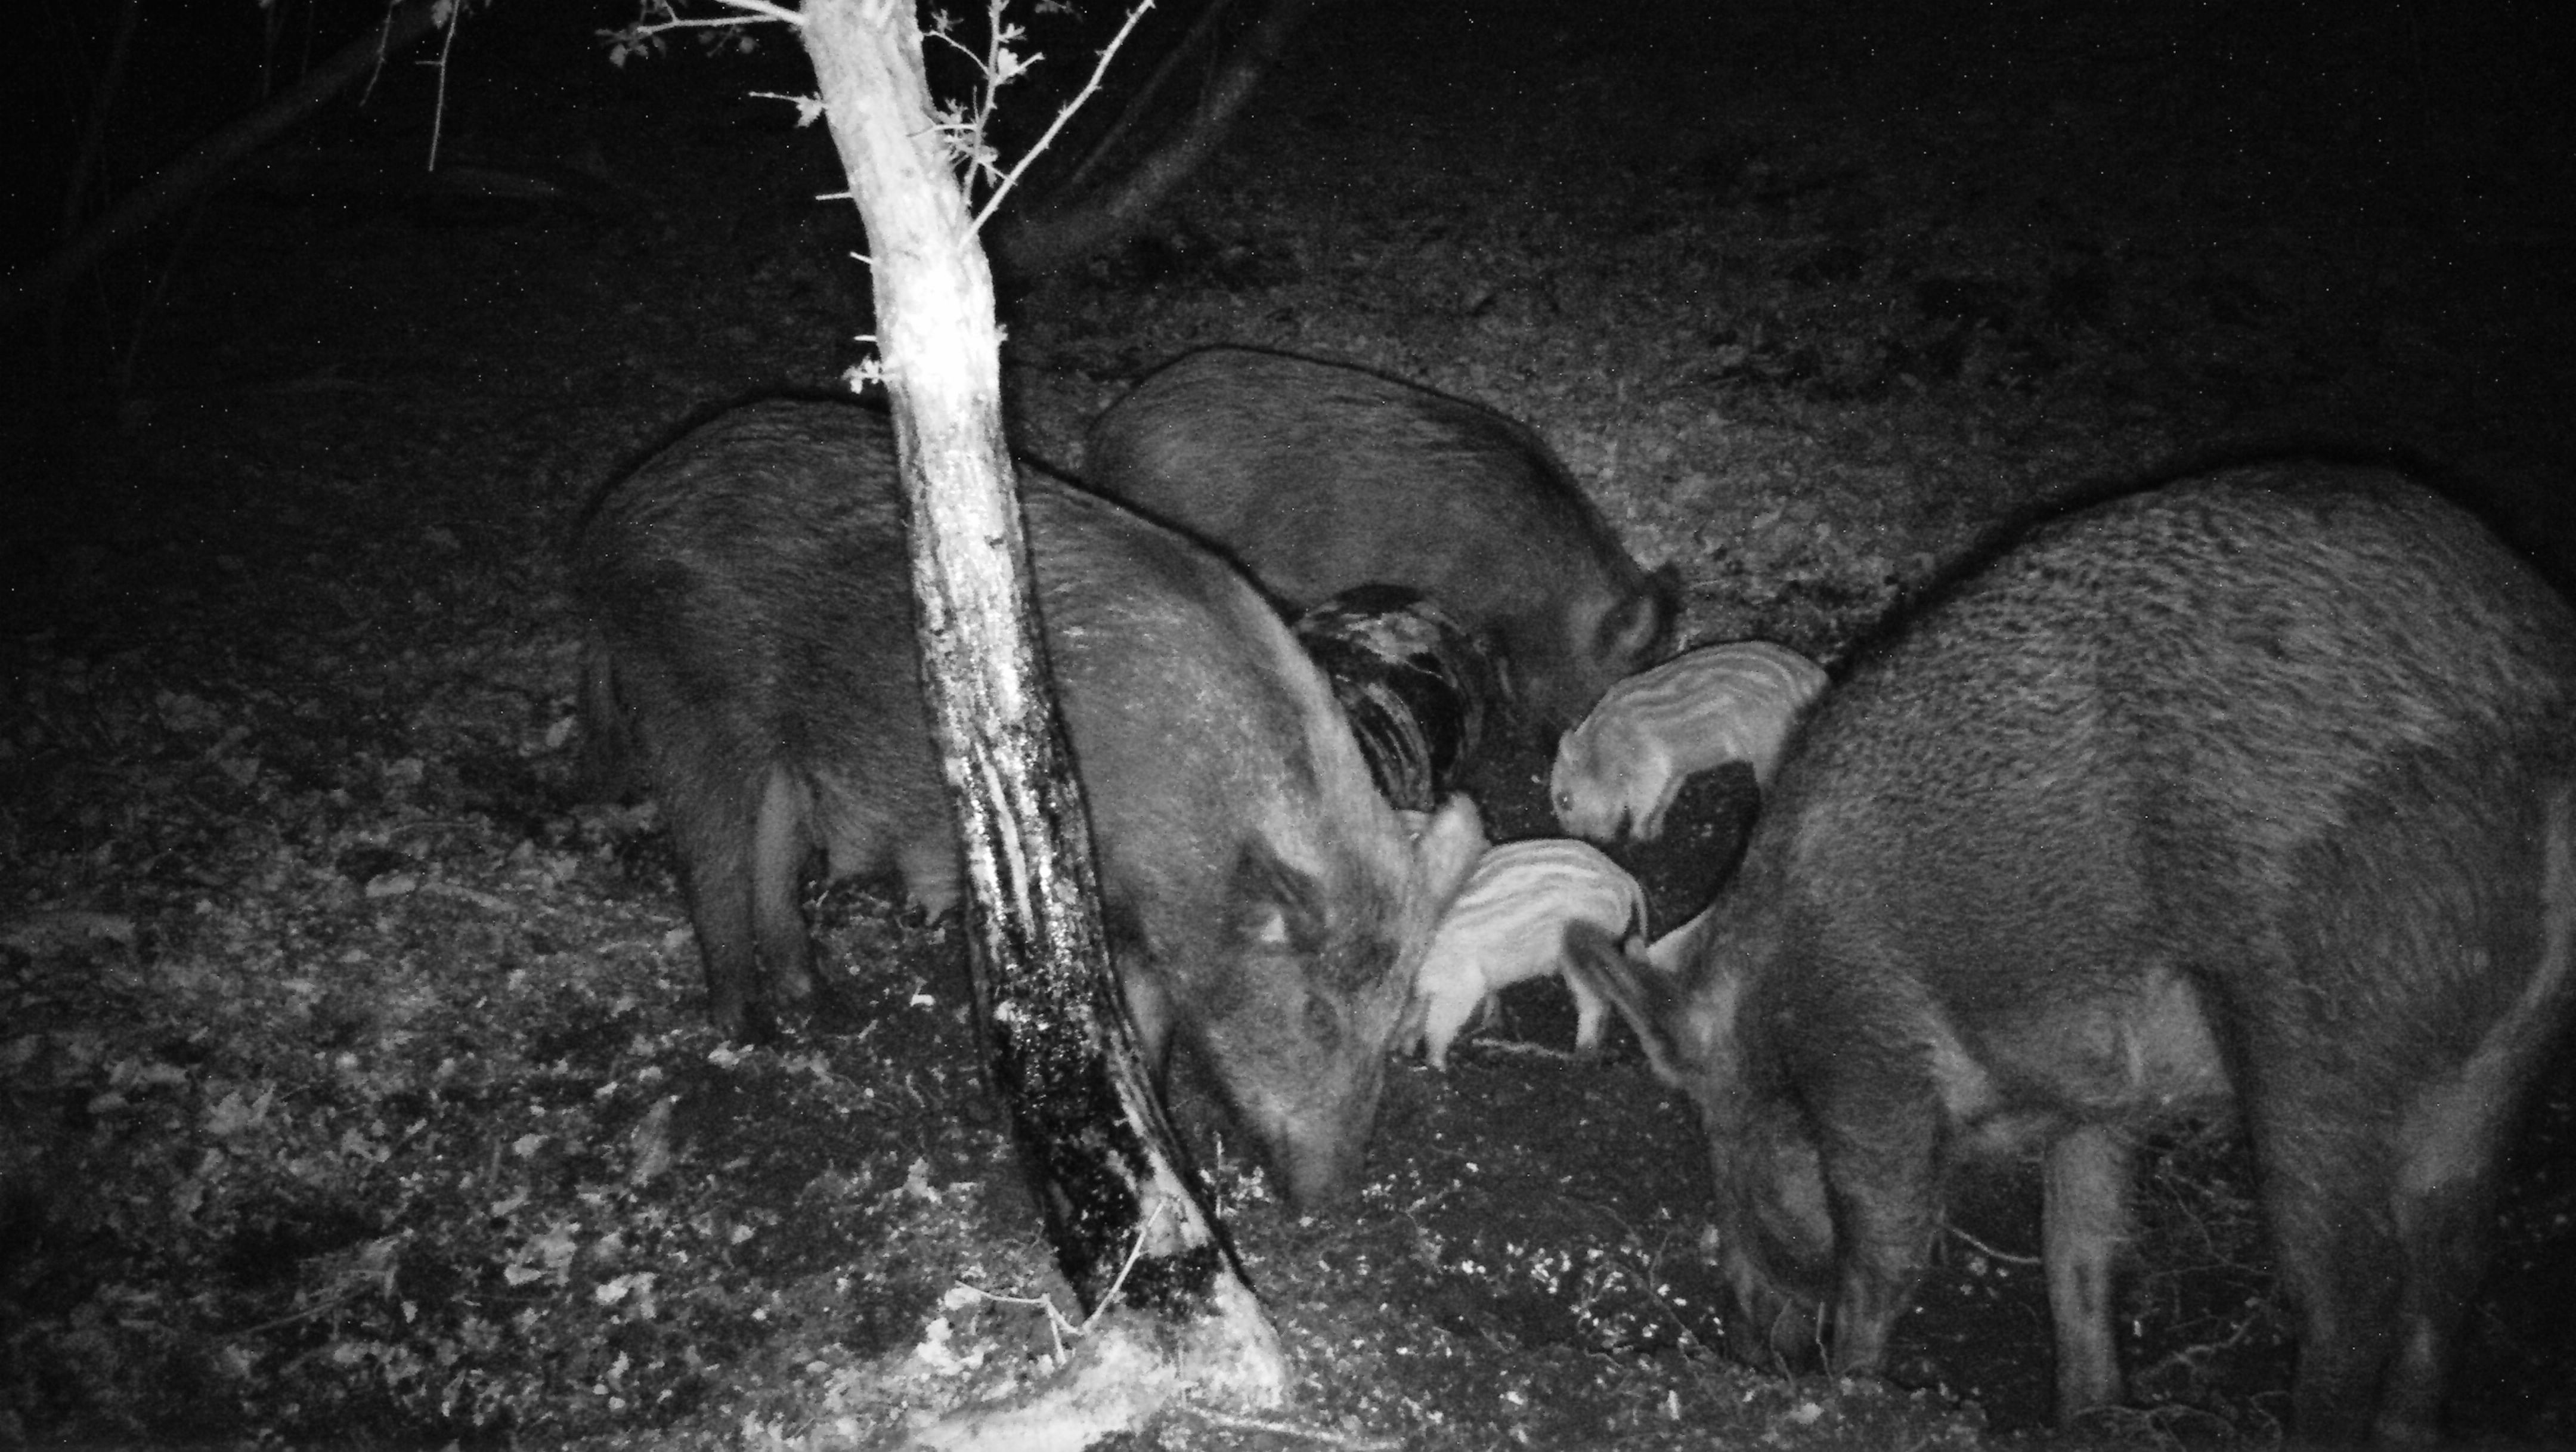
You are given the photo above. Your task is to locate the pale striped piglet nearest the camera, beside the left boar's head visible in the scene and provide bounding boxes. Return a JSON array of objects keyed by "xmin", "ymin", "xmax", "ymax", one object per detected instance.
[{"xmin": 1396, "ymin": 837, "xmax": 1646, "ymax": 1069}]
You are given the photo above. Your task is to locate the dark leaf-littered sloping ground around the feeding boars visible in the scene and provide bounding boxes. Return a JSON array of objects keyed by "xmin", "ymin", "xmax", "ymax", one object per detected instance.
[{"xmin": 0, "ymin": 2, "xmax": 2576, "ymax": 1450}]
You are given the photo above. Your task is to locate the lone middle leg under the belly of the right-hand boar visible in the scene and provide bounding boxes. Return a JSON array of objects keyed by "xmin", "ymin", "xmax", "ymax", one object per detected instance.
[{"xmin": 2040, "ymin": 1125, "xmax": 2131, "ymax": 1426}]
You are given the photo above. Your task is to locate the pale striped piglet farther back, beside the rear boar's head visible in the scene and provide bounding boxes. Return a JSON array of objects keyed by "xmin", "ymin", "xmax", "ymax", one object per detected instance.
[{"xmin": 1548, "ymin": 641, "xmax": 1824, "ymax": 842}]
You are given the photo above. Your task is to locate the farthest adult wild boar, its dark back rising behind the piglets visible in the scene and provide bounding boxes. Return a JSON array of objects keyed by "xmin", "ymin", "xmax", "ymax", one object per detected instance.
[{"xmin": 1082, "ymin": 348, "xmax": 1677, "ymax": 733}]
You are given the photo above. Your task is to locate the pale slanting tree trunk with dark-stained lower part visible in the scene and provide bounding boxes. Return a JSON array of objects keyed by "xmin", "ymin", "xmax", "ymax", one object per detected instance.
[{"xmin": 804, "ymin": 0, "xmax": 1286, "ymax": 1447}]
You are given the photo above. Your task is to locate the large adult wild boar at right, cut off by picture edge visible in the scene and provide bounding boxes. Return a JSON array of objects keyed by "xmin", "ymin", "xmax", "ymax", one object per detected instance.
[{"xmin": 1569, "ymin": 463, "xmax": 2576, "ymax": 1444}]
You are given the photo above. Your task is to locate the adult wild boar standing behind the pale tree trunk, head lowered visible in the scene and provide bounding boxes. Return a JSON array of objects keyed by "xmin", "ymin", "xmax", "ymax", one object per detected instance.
[{"xmin": 574, "ymin": 402, "xmax": 1484, "ymax": 1205}]
